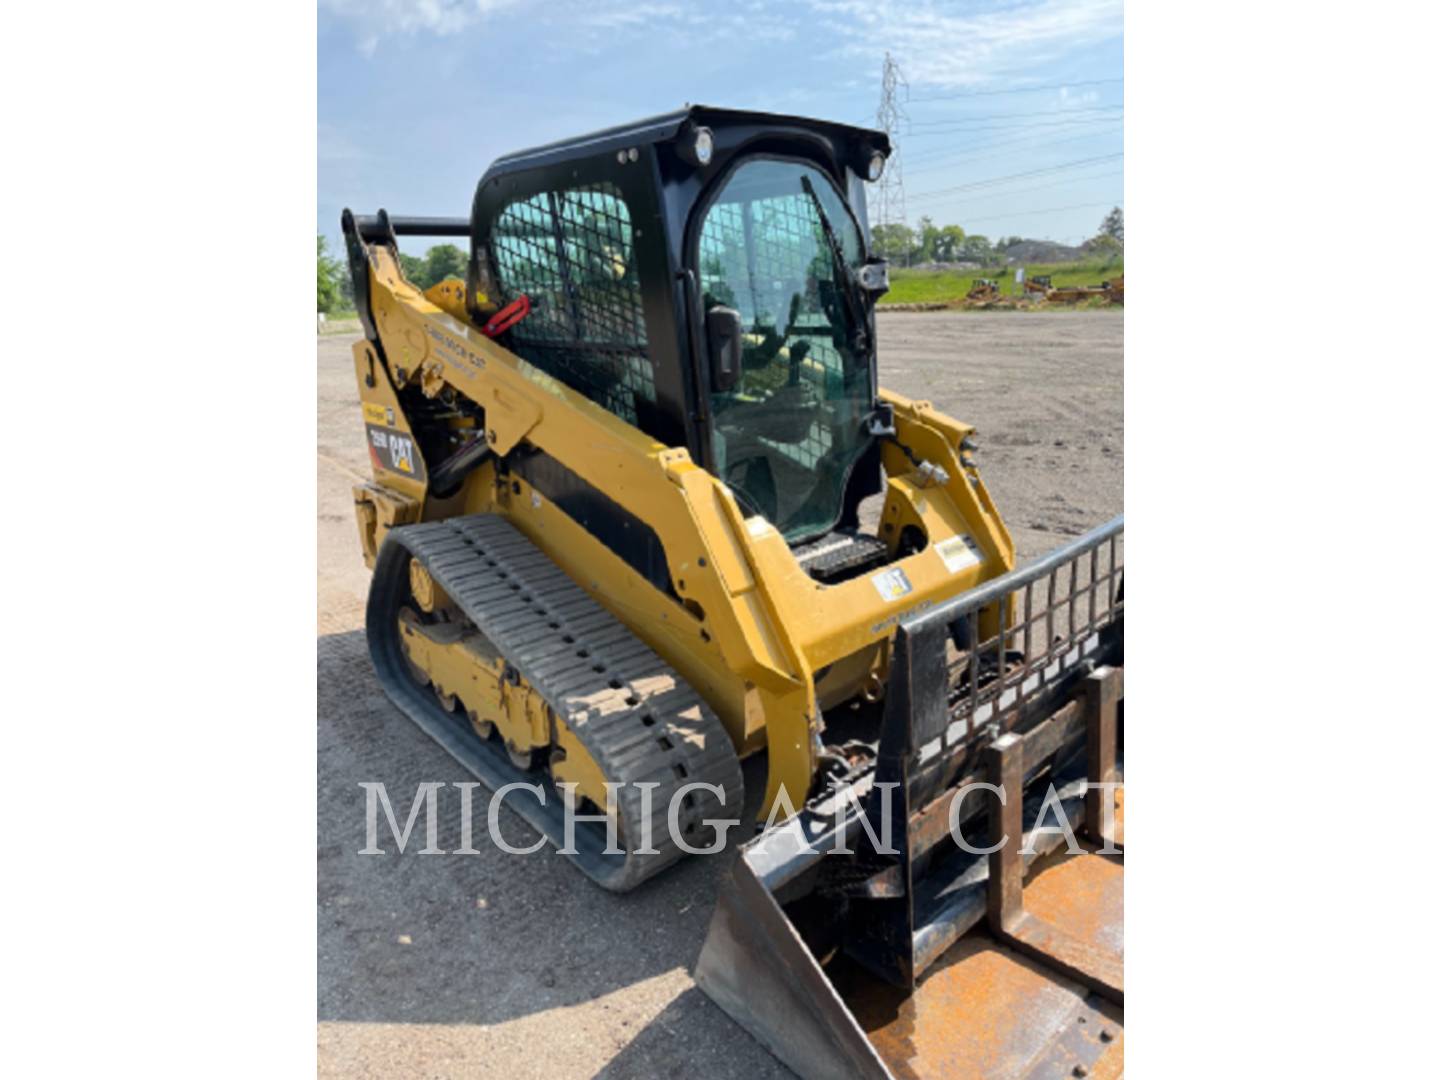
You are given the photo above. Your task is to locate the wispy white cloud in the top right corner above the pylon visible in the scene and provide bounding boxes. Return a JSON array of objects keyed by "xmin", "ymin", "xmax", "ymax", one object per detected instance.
[{"xmin": 808, "ymin": 0, "xmax": 1125, "ymax": 88}]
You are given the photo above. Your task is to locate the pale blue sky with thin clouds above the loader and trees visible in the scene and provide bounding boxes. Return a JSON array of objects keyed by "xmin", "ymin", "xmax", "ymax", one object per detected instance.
[{"xmin": 317, "ymin": 0, "xmax": 1125, "ymax": 252}]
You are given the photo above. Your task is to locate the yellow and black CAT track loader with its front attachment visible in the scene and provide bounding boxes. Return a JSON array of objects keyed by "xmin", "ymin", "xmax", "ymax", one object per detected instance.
[{"xmin": 343, "ymin": 107, "xmax": 1125, "ymax": 1077}]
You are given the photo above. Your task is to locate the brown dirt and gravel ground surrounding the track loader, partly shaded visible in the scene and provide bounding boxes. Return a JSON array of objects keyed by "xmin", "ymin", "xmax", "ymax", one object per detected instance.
[{"xmin": 317, "ymin": 311, "xmax": 1125, "ymax": 1080}]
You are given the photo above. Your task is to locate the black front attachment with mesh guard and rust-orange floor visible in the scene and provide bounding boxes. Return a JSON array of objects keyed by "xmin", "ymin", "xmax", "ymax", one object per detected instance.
[{"xmin": 696, "ymin": 518, "xmax": 1125, "ymax": 1077}]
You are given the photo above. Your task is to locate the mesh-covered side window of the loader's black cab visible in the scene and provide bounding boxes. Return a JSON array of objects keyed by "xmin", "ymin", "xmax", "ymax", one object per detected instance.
[{"xmin": 491, "ymin": 184, "xmax": 655, "ymax": 428}]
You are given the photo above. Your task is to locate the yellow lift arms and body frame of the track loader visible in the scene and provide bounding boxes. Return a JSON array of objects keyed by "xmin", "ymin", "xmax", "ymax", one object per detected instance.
[{"xmin": 354, "ymin": 243, "xmax": 1015, "ymax": 815}]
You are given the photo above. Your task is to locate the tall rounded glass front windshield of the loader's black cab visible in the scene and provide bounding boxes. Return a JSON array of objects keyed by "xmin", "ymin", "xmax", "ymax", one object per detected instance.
[{"xmin": 700, "ymin": 160, "xmax": 873, "ymax": 541}]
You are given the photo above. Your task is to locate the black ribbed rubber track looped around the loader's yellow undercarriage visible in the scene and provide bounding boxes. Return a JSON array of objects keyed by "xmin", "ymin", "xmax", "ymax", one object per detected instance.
[{"xmin": 366, "ymin": 514, "xmax": 744, "ymax": 891}]
